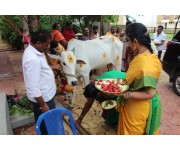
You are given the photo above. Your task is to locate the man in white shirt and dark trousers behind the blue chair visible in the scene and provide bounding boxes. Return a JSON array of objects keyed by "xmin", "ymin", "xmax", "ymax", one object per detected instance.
[{"xmin": 22, "ymin": 30, "xmax": 56, "ymax": 134}]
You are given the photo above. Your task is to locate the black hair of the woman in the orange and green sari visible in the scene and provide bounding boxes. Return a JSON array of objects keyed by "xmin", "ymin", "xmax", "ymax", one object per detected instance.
[{"xmin": 125, "ymin": 23, "xmax": 153, "ymax": 53}]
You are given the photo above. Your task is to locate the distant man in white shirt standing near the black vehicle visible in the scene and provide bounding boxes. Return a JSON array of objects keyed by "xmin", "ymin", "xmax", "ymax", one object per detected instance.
[{"xmin": 152, "ymin": 25, "xmax": 166, "ymax": 60}]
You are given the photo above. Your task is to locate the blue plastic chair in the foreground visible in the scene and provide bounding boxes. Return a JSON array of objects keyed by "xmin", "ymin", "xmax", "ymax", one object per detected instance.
[{"xmin": 36, "ymin": 107, "xmax": 77, "ymax": 135}]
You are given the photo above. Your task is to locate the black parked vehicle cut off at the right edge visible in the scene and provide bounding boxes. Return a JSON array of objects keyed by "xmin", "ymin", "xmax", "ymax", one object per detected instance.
[{"xmin": 163, "ymin": 30, "xmax": 180, "ymax": 96}]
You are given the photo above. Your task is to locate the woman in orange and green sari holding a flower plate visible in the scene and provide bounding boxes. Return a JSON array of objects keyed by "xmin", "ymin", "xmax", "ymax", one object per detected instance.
[{"xmin": 117, "ymin": 23, "xmax": 162, "ymax": 135}]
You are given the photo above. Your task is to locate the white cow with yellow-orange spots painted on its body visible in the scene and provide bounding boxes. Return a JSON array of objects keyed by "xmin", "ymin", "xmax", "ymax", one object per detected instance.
[{"xmin": 50, "ymin": 36, "xmax": 123, "ymax": 107}]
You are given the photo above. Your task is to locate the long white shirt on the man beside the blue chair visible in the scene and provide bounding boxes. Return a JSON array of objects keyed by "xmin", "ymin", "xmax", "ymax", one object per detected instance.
[{"xmin": 22, "ymin": 45, "xmax": 56, "ymax": 102}]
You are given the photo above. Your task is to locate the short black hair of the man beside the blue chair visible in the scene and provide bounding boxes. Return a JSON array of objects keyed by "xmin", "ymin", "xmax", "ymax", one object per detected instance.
[{"xmin": 31, "ymin": 29, "xmax": 51, "ymax": 44}]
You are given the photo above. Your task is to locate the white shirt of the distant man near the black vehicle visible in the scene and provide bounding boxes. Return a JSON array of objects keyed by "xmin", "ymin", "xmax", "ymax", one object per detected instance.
[{"xmin": 152, "ymin": 32, "xmax": 166, "ymax": 51}]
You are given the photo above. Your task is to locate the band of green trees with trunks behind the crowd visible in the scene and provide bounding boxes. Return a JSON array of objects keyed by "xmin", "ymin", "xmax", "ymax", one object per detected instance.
[{"xmin": 0, "ymin": 15, "xmax": 118, "ymax": 49}]
